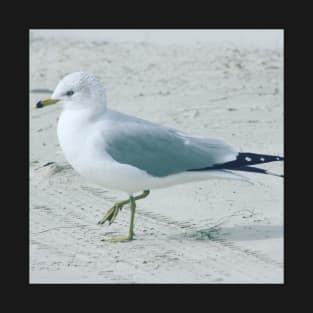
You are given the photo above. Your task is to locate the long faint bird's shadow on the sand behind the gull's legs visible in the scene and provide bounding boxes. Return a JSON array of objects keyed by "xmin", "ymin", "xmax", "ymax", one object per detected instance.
[{"xmin": 171, "ymin": 225, "xmax": 284, "ymax": 241}]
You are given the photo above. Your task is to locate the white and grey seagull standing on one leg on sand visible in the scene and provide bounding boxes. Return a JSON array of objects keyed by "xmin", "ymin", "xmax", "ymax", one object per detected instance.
[{"xmin": 35, "ymin": 72, "xmax": 284, "ymax": 242}]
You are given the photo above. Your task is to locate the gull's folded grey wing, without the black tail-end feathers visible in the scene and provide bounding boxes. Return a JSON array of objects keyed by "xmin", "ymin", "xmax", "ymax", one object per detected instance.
[{"xmin": 105, "ymin": 115, "xmax": 238, "ymax": 177}]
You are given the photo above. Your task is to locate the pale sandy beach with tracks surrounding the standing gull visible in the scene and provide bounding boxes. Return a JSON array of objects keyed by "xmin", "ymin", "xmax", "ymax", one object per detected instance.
[{"xmin": 29, "ymin": 30, "xmax": 284, "ymax": 284}]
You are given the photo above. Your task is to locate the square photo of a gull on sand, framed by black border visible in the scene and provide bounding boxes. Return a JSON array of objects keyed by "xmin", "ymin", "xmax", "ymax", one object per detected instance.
[{"xmin": 29, "ymin": 29, "xmax": 284, "ymax": 284}]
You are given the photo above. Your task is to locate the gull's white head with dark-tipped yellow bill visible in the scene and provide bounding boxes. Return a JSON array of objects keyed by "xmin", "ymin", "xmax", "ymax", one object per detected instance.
[{"xmin": 36, "ymin": 72, "xmax": 106, "ymax": 111}]
